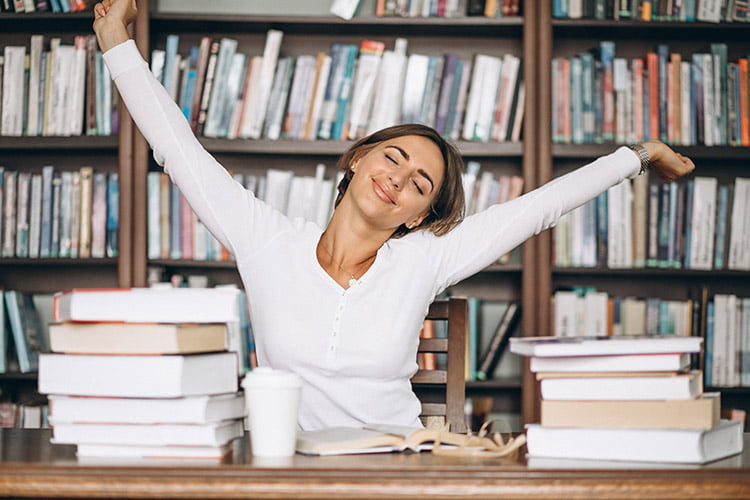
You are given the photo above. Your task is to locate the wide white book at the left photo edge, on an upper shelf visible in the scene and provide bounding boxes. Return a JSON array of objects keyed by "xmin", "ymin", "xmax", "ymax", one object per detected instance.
[{"xmin": 0, "ymin": 45, "xmax": 26, "ymax": 136}]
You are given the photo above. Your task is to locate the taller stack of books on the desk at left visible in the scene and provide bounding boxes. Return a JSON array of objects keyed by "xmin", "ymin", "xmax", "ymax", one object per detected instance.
[{"xmin": 39, "ymin": 288, "xmax": 245, "ymax": 458}]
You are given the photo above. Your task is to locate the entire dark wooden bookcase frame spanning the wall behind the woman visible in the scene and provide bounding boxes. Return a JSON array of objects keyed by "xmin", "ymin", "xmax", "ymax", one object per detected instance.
[{"xmin": 5, "ymin": 0, "xmax": 750, "ymax": 428}]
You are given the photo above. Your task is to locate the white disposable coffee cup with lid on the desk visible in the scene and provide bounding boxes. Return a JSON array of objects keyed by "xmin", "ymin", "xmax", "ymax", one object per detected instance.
[{"xmin": 242, "ymin": 367, "xmax": 302, "ymax": 457}]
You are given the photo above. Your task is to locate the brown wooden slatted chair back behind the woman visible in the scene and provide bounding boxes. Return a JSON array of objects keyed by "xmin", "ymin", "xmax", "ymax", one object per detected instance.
[{"xmin": 412, "ymin": 297, "xmax": 469, "ymax": 432}]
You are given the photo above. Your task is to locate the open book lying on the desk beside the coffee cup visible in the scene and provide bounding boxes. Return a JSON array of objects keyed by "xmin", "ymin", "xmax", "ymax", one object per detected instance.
[{"xmin": 297, "ymin": 424, "xmax": 468, "ymax": 455}]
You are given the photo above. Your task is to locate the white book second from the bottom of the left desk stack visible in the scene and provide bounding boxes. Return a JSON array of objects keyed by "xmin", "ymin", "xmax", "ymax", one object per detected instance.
[{"xmin": 52, "ymin": 420, "xmax": 244, "ymax": 446}]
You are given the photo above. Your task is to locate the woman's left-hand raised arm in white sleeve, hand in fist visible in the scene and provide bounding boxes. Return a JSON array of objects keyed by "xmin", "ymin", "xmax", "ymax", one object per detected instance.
[{"xmin": 89, "ymin": 0, "xmax": 285, "ymax": 255}]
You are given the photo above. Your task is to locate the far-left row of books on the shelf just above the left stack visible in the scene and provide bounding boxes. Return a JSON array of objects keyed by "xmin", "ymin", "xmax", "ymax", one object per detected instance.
[{"xmin": 0, "ymin": 165, "xmax": 119, "ymax": 259}]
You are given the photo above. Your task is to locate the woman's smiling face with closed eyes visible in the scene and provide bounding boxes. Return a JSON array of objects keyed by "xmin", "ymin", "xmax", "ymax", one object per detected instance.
[{"xmin": 346, "ymin": 135, "xmax": 444, "ymax": 231}]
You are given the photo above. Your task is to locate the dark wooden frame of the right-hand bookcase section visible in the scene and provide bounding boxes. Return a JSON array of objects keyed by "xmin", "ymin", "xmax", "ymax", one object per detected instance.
[{"xmin": 536, "ymin": 2, "xmax": 750, "ymax": 418}]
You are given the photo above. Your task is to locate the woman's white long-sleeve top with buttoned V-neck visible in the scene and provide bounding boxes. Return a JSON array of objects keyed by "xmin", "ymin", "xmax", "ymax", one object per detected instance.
[{"xmin": 104, "ymin": 40, "xmax": 639, "ymax": 430}]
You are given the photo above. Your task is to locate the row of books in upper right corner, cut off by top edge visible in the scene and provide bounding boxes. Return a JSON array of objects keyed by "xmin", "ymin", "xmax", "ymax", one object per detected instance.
[{"xmin": 552, "ymin": 0, "xmax": 750, "ymax": 23}]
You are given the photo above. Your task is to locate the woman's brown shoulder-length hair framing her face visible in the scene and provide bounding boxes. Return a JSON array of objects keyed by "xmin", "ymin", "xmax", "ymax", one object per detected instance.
[{"xmin": 334, "ymin": 123, "xmax": 465, "ymax": 238}]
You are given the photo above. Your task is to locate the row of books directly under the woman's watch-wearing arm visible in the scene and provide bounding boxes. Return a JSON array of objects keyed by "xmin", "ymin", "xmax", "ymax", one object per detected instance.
[{"xmin": 554, "ymin": 174, "xmax": 750, "ymax": 271}]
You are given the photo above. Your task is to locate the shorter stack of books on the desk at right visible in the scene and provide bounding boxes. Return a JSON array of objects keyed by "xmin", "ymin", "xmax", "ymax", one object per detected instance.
[{"xmin": 511, "ymin": 335, "xmax": 743, "ymax": 463}]
